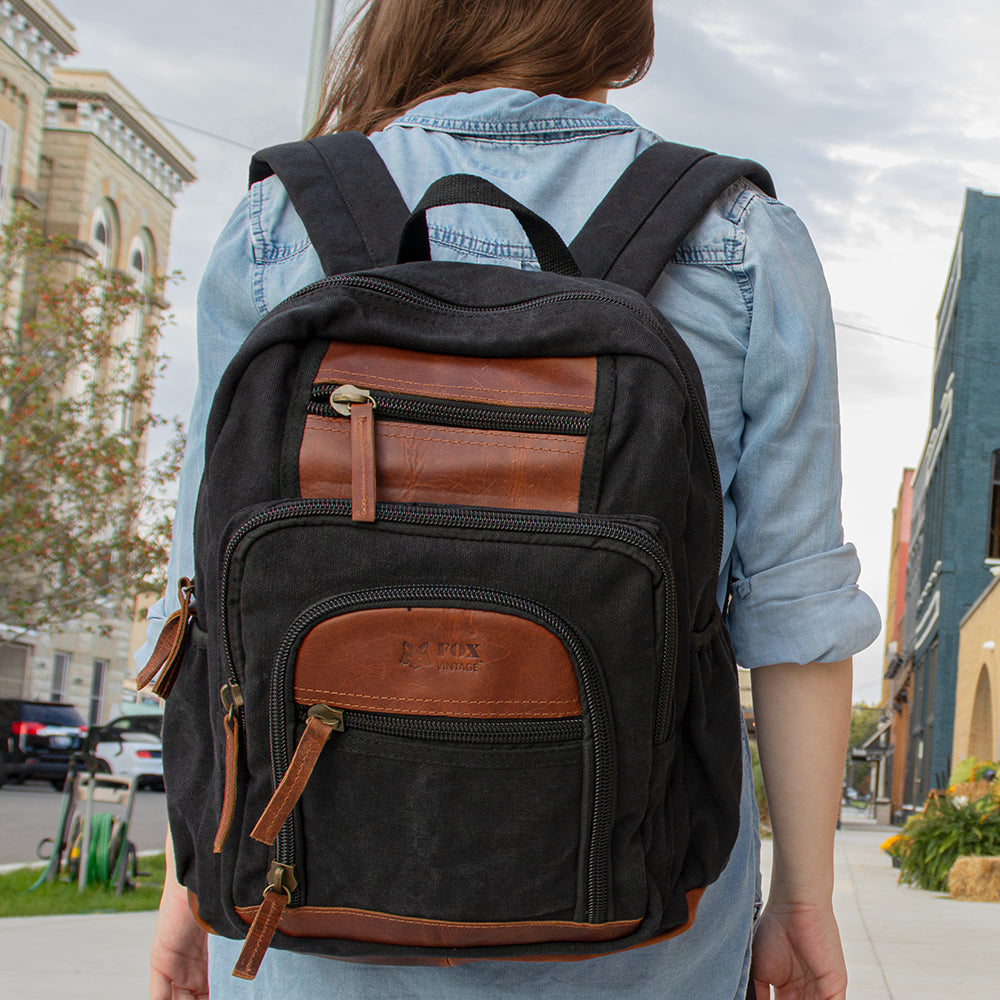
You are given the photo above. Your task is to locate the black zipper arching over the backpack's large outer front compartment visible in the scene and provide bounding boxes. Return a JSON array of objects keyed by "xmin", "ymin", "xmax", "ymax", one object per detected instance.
[{"xmin": 218, "ymin": 498, "xmax": 677, "ymax": 743}]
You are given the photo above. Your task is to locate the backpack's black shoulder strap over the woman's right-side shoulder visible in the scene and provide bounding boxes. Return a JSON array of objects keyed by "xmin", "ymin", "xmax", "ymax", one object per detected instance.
[{"xmin": 570, "ymin": 142, "xmax": 774, "ymax": 295}]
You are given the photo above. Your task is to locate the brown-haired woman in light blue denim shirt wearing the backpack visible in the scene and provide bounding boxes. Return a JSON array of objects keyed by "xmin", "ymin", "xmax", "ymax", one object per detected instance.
[{"xmin": 150, "ymin": 0, "xmax": 878, "ymax": 1000}]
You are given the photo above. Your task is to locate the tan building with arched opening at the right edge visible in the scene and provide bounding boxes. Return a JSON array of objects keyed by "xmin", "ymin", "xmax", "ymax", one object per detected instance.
[{"xmin": 951, "ymin": 574, "xmax": 1000, "ymax": 763}]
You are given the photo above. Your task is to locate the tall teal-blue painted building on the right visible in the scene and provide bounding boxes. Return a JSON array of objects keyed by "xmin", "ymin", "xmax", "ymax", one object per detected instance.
[{"xmin": 896, "ymin": 191, "xmax": 1000, "ymax": 805}]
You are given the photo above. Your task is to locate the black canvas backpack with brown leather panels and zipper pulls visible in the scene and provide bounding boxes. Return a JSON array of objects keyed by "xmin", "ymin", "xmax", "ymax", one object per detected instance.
[{"xmin": 139, "ymin": 133, "xmax": 772, "ymax": 978}]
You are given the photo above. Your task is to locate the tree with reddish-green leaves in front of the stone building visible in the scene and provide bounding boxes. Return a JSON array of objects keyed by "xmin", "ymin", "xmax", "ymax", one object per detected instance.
[{"xmin": 0, "ymin": 215, "xmax": 182, "ymax": 629}]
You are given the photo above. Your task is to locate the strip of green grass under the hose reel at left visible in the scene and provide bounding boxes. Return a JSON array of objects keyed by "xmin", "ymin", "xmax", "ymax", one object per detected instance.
[{"xmin": 0, "ymin": 854, "xmax": 165, "ymax": 917}]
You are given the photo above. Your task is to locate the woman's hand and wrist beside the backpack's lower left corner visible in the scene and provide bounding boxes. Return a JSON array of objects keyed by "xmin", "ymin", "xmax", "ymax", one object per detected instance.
[{"xmin": 149, "ymin": 834, "xmax": 208, "ymax": 1000}]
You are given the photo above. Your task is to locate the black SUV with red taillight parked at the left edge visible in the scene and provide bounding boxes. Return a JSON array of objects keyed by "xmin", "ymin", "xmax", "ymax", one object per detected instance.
[{"xmin": 0, "ymin": 698, "xmax": 87, "ymax": 789}]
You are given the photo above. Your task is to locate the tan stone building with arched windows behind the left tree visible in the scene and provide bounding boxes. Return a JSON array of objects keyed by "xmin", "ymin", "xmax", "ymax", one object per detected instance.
[{"xmin": 0, "ymin": 0, "xmax": 195, "ymax": 723}]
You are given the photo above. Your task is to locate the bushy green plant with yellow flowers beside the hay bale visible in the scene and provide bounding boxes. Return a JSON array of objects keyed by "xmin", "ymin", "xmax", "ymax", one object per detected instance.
[{"xmin": 882, "ymin": 795, "xmax": 1000, "ymax": 892}]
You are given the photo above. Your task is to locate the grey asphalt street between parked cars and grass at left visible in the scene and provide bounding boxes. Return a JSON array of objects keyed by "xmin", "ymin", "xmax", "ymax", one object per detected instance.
[{"xmin": 0, "ymin": 781, "xmax": 167, "ymax": 865}]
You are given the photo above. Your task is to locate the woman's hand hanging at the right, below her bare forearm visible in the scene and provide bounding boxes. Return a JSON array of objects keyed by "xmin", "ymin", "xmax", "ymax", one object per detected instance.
[{"xmin": 748, "ymin": 901, "xmax": 847, "ymax": 1000}]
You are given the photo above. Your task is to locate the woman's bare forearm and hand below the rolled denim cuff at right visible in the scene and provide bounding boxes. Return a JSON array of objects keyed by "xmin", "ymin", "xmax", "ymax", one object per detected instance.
[{"xmin": 750, "ymin": 660, "xmax": 852, "ymax": 1000}]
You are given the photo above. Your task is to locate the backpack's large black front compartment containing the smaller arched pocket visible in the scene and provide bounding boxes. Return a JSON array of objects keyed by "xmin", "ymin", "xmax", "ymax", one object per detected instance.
[{"xmin": 220, "ymin": 500, "xmax": 675, "ymax": 947}]
